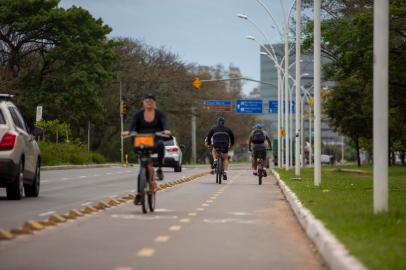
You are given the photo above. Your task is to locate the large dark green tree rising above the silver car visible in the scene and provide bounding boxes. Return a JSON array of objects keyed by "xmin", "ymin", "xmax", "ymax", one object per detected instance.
[{"xmin": 0, "ymin": 0, "xmax": 115, "ymax": 134}]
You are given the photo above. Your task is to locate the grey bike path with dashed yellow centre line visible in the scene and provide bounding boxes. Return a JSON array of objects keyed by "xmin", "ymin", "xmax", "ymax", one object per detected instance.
[{"xmin": 0, "ymin": 169, "xmax": 325, "ymax": 270}]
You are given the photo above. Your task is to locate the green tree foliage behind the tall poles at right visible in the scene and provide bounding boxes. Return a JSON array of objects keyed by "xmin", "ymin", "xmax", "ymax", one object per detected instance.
[{"xmin": 304, "ymin": 0, "xmax": 406, "ymax": 165}]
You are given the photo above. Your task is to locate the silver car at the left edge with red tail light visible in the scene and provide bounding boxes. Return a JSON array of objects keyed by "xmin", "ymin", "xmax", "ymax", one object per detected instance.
[{"xmin": 0, "ymin": 94, "xmax": 42, "ymax": 200}]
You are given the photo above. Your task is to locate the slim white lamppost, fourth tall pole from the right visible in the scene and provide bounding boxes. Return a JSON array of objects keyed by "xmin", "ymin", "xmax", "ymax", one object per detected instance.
[{"xmin": 284, "ymin": 18, "xmax": 289, "ymax": 170}]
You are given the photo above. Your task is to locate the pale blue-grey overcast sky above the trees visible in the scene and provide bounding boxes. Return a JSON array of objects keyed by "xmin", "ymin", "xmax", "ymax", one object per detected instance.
[{"xmin": 60, "ymin": 0, "xmax": 292, "ymax": 94}]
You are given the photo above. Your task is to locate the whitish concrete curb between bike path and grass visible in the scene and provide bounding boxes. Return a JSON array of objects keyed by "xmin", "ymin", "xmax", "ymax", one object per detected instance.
[{"xmin": 272, "ymin": 170, "xmax": 367, "ymax": 270}]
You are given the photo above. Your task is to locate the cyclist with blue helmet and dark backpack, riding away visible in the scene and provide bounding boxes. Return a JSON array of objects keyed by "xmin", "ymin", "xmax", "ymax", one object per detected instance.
[{"xmin": 248, "ymin": 123, "xmax": 272, "ymax": 176}]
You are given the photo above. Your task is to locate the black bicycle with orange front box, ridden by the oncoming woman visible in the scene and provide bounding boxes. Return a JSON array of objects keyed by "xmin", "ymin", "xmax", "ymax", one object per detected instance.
[{"xmin": 130, "ymin": 132, "xmax": 170, "ymax": 214}]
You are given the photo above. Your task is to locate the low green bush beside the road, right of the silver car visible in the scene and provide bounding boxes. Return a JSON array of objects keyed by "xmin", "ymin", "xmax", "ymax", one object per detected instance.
[{"xmin": 39, "ymin": 142, "xmax": 106, "ymax": 166}]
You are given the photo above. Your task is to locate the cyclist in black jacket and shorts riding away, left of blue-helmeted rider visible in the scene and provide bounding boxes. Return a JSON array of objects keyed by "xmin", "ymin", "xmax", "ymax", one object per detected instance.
[{"xmin": 207, "ymin": 117, "xmax": 234, "ymax": 180}]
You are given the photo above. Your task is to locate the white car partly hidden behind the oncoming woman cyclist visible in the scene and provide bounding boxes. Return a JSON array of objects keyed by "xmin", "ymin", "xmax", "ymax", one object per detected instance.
[{"xmin": 152, "ymin": 137, "xmax": 183, "ymax": 172}]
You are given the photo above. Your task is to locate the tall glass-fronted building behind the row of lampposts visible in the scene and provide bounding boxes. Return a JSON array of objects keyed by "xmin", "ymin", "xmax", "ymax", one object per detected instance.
[{"xmin": 260, "ymin": 43, "xmax": 341, "ymax": 148}]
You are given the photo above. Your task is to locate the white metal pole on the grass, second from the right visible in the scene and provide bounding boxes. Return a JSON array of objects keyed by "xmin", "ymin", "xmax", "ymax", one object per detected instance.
[{"xmin": 314, "ymin": 0, "xmax": 321, "ymax": 186}]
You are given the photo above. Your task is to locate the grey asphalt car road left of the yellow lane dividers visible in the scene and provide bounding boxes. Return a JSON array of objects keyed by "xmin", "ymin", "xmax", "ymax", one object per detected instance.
[{"xmin": 0, "ymin": 166, "xmax": 208, "ymax": 229}]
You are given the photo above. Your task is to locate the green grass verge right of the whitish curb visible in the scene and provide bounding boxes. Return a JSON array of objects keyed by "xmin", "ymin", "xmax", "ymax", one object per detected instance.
[{"xmin": 277, "ymin": 166, "xmax": 406, "ymax": 269}]
